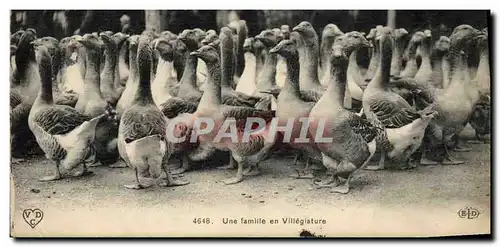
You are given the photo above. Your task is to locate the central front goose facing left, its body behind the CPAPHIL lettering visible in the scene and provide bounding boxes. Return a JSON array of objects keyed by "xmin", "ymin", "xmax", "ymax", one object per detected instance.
[{"xmin": 191, "ymin": 43, "xmax": 277, "ymax": 185}]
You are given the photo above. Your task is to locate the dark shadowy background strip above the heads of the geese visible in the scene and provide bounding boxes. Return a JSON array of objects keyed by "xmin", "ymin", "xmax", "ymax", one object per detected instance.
[{"xmin": 11, "ymin": 10, "xmax": 489, "ymax": 39}]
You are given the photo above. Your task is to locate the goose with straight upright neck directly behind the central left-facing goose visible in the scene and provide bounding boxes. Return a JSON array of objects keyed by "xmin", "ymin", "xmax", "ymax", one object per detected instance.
[{"xmin": 220, "ymin": 27, "xmax": 265, "ymax": 107}]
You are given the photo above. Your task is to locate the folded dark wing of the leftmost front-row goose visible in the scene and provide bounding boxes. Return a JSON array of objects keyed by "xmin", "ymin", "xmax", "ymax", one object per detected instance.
[{"xmin": 34, "ymin": 105, "xmax": 91, "ymax": 135}]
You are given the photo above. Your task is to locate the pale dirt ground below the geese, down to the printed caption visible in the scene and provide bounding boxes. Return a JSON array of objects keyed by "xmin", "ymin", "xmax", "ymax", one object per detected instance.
[{"xmin": 11, "ymin": 127, "xmax": 491, "ymax": 237}]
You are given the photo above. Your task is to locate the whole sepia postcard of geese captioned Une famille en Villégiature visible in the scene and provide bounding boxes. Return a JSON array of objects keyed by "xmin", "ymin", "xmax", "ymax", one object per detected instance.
[{"xmin": 5, "ymin": 4, "xmax": 494, "ymax": 239}]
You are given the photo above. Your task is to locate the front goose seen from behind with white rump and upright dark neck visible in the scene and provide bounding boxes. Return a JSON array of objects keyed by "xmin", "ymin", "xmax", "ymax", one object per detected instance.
[{"xmin": 118, "ymin": 35, "xmax": 189, "ymax": 189}]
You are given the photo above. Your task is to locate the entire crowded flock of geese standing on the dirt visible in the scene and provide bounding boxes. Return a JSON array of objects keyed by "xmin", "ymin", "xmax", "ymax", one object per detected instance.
[{"xmin": 10, "ymin": 20, "xmax": 490, "ymax": 193}]
